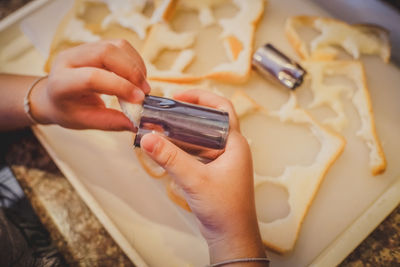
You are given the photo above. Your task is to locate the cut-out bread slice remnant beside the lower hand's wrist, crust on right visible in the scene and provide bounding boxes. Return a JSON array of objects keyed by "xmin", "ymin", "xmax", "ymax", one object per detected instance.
[{"xmin": 233, "ymin": 92, "xmax": 345, "ymax": 253}]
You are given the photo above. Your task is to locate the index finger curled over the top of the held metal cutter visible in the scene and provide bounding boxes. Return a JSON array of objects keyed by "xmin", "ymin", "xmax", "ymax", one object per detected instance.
[{"xmin": 174, "ymin": 89, "xmax": 239, "ymax": 130}]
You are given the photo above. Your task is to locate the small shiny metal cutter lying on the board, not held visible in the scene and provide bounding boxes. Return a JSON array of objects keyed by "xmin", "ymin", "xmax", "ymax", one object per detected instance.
[{"xmin": 252, "ymin": 44, "xmax": 306, "ymax": 90}]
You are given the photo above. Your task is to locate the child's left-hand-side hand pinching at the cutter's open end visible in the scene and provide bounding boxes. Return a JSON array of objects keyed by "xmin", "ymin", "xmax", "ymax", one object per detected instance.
[{"xmin": 30, "ymin": 40, "xmax": 150, "ymax": 131}]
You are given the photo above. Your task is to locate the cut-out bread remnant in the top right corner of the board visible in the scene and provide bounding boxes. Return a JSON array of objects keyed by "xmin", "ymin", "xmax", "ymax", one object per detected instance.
[{"xmin": 285, "ymin": 16, "xmax": 390, "ymax": 63}]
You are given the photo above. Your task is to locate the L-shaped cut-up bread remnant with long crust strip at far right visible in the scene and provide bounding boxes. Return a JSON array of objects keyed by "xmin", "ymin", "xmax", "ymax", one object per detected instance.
[{"xmin": 302, "ymin": 61, "xmax": 386, "ymax": 175}]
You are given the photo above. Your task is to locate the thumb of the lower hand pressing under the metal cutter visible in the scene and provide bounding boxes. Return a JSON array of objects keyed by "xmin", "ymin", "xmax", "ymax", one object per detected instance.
[{"xmin": 140, "ymin": 133, "xmax": 203, "ymax": 188}]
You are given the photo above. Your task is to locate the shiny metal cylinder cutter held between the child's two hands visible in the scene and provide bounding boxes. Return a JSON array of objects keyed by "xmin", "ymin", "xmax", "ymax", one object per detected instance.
[{"xmin": 134, "ymin": 96, "xmax": 229, "ymax": 162}]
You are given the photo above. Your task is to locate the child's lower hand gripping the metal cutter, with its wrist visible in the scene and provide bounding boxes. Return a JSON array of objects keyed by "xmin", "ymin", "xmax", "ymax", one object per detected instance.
[{"xmin": 141, "ymin": 90, "xmax": 265, "ymax": 266}]
